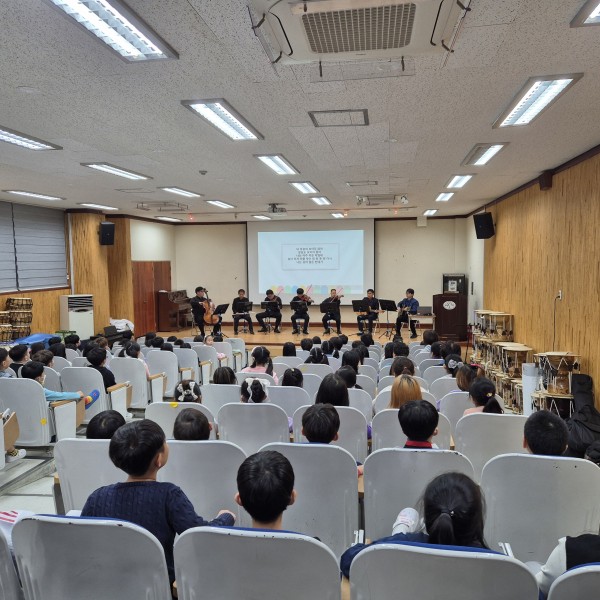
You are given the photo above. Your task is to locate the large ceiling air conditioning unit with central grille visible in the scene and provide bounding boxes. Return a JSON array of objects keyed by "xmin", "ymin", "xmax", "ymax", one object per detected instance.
[{"xmin": 248, "ymin": 0, "xmax": 468, "ymax": 64}]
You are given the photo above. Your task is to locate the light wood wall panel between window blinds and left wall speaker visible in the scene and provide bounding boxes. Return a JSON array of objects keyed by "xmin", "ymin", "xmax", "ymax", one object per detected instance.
[{"xmin": 69, "ymin": 213, "xmax": 110, "ymax": 332}]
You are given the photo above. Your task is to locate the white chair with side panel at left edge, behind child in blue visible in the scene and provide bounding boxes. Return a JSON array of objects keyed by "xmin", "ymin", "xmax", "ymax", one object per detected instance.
[{"xmin": 0, "ymin": 377, "xmax": 77, "ymax": 448}]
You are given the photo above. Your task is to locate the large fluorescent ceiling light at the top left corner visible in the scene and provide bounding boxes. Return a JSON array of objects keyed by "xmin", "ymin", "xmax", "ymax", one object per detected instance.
[{"xmin": 46, "ymin": 0, "xmax": 179, "ymax": 62}]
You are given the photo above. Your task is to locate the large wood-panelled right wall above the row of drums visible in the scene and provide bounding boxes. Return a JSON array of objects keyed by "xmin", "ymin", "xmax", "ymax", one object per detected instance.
[{"xmin": 484, "ymin": 156, "xmax": 600, "ymax": 406}]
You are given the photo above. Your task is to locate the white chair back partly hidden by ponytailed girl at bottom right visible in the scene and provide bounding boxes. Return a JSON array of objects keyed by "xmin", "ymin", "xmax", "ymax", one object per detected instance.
[{"xmin": 364, "ymin": 448, "xmax": 476, "ymax": 542}]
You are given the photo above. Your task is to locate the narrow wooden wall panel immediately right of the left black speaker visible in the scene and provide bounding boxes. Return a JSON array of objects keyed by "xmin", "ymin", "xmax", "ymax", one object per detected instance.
[{"xmin": 107, "ymin": 219, "xmax": 135, "ymax": 324}]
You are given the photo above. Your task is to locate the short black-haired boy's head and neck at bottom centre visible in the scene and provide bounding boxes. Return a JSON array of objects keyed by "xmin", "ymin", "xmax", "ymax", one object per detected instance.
[{"xmin": 235, "ymin": 450, "xmax": 296, "ymax": 530}]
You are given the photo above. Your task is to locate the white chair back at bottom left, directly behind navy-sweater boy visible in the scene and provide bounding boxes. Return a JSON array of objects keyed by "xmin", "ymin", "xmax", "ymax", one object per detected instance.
[{"xmin": 13, "ymin": 515, "xmax": 170, "ymax": 600}]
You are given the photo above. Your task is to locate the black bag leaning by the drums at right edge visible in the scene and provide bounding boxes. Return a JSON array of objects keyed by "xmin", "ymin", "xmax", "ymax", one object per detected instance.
[{"xmin": 567, "ymin": 374, "xmax": 600, "ymax": 458}]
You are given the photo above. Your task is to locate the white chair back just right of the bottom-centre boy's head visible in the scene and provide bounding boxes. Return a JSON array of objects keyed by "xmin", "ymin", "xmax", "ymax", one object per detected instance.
[{"xmin": 262, "ymin": 444, "xmax": 359, "ymax": 558}]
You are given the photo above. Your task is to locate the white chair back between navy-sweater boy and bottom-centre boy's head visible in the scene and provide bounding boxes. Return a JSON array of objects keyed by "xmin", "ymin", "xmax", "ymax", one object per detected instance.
[{"xmin": 158, "ymin": 440, "xmax": 250, "ymax": 525}]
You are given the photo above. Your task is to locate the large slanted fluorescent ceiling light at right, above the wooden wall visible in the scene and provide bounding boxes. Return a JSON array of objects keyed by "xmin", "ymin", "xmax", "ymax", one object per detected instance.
[{"xmin": 493, "ymin": 73, "xmax": 583, "ymax": 128}]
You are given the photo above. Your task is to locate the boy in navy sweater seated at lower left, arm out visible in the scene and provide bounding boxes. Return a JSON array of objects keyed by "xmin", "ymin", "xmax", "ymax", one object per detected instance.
[{"xmin": 81, "ymin": 419, "xmax": 235, "ymax": 582}]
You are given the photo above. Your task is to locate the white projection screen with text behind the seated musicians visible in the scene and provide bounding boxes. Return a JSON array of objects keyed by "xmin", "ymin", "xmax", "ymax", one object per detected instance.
[{"xmin": 247, "ymin": 219, "xmax": 375, "ymax": 305}]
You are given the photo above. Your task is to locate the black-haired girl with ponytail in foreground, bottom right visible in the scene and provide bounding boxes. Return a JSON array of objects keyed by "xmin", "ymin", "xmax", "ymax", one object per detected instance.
[{"xmin": 340, "ymin": 473, "xmax": 497, "ymax": 577}]
